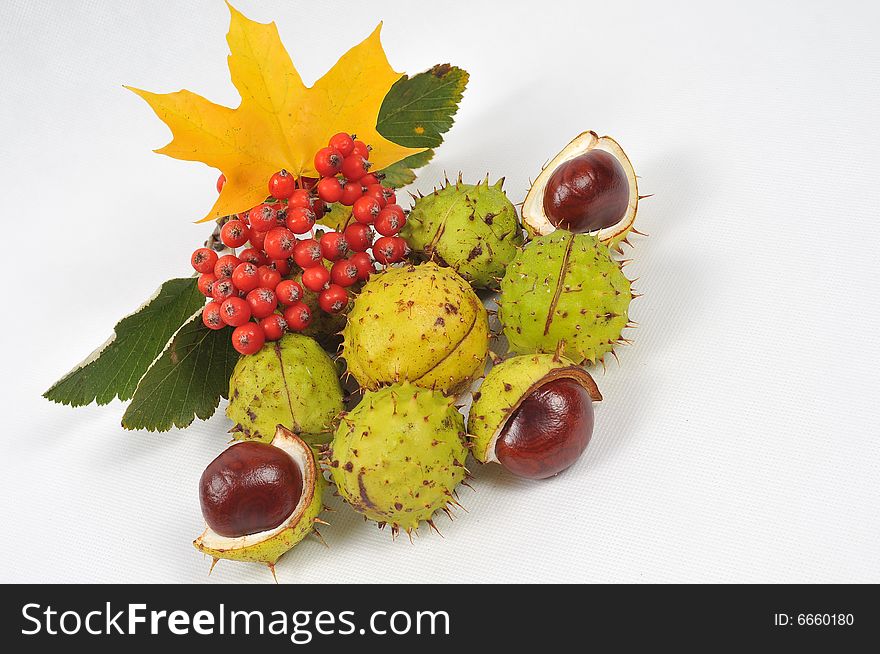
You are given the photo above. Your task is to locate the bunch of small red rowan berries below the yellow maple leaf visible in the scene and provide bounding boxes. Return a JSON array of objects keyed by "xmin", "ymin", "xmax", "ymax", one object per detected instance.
[{"xmin": 192, "ymin": 133, "xmax": 409, "ymax": 354}]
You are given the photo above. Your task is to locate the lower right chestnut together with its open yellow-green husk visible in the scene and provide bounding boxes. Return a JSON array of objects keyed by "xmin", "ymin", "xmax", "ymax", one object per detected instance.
[{"xmin": 468, "ymin": 354, "xmax": 602, "ymax": 479}]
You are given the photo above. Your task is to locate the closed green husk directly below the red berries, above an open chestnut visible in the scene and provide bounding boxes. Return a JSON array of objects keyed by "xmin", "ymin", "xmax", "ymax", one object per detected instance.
[{"xmin": 226, "ymin": 334, "xmax": 343, "ymax": 444}]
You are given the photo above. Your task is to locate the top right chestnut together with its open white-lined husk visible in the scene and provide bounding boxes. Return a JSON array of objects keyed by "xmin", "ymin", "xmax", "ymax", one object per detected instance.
[{"xmin": 522, "ymin": 132, "xmax": 639, "ymax": 247}]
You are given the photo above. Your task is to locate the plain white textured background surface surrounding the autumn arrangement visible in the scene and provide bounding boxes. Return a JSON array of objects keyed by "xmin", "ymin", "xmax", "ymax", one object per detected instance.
[{"xmin": 0, "ymin": 0, "xmax": 880, "ymax": 583}]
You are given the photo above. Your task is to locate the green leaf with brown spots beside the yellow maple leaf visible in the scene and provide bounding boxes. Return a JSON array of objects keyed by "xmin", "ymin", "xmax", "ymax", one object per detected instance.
[{"xmin": 376, "ymin": 64, "xmax": 468, "ymax": 187}]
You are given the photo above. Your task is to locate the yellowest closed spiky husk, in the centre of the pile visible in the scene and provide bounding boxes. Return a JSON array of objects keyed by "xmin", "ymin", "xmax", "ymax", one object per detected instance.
[{"xmin": 342, "ymin": 262, "xmax": 489, "ymax": 394}]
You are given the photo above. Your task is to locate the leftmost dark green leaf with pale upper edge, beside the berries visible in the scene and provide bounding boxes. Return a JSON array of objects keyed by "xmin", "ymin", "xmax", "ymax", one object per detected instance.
[{"xmin": 43, "ymin": 278, "xmax": 205, "ymax": 406}]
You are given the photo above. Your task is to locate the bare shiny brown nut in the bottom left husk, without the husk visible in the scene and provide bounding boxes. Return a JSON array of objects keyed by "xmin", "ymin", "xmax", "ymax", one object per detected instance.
[{"xmin": 199, "ymin": 441, "xmax": 303, "ymax": 538}]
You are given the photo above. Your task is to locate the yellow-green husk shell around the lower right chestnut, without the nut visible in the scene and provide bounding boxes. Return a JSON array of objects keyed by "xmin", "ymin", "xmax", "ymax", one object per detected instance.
[{"xmin": 468, "ymin": 354, "xmax": 602, "ymax": 463}]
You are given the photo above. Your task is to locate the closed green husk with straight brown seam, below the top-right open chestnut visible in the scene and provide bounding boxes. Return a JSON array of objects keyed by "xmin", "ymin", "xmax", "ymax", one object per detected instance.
[{"xmin": 498, "ymin": 230, "xmax": 633, "ymax": 363}]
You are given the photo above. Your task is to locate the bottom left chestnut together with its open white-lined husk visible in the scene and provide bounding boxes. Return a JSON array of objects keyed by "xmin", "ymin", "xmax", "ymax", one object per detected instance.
[{"xmin": 193, "ymin": 425, "xmax": 325, "ymax": 572}]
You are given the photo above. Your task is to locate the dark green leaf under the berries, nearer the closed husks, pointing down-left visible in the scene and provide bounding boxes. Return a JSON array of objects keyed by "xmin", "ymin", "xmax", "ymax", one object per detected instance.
[{"xmin": 122, "ymin": 312, "xmax": 239, "ymax": 431}]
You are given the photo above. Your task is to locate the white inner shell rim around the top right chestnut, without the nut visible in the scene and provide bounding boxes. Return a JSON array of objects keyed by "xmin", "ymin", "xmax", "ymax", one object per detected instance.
[{"xmin": 522, "ymin": 132, "xmax": 639, "ymax": 241}]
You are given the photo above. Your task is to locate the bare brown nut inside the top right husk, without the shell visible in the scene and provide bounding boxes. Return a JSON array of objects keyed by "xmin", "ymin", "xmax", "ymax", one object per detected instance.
[{"xmin": 544, "ymin": 149, "xmax": 629, "ymax": 234}]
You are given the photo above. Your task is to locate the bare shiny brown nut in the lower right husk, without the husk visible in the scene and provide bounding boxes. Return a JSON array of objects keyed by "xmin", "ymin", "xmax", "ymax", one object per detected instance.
[{"xmin": 495, "ymin": 377, "xmax": 593, "ymax": 479}]
